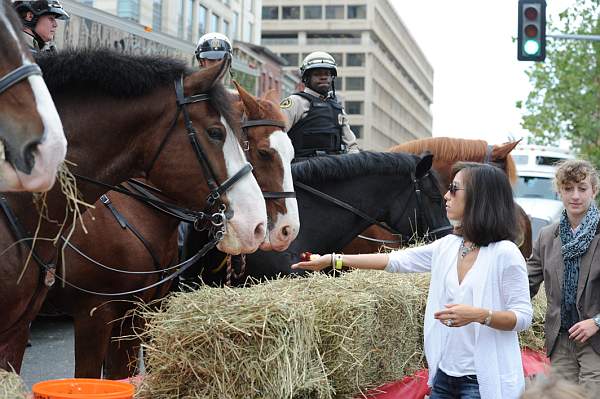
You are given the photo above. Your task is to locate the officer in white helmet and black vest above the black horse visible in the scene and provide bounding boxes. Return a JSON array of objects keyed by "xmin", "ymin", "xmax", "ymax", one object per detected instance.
[{"xmin": 280, "ymin": 51, "xmax": 359, "ymax": 158}]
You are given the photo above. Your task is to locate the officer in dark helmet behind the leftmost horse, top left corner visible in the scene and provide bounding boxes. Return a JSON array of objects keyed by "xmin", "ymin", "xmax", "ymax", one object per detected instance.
[{"xmin": 13, "ymin": 0, "xmax": 70, "ymax": 54}]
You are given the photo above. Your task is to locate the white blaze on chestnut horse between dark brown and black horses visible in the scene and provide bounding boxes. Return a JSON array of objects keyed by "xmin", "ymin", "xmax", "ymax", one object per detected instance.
[{"xmin": 261, "ymin": 130, "xmax": 300, "ymax": 251}]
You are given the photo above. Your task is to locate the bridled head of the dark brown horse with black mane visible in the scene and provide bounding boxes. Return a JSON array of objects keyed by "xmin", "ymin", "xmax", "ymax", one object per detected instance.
[{"xmin": 142, "ymin": 59, "xmax": 267, "ymax": 254}]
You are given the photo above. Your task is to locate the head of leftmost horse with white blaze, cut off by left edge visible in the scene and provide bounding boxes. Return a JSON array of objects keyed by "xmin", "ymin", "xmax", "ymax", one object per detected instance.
[{"xmin": 0, "ymin": 0, "xmax": 67, "ymax": 192}]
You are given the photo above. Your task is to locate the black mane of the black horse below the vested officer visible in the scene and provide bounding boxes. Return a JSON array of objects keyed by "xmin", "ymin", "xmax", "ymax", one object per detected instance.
[{"xmin": 292, "ymin": 151, "xmax": 418, "ymax": 183}]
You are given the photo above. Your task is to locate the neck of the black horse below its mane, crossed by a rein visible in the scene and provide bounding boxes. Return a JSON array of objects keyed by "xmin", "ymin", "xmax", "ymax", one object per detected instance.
[{"xmin": 291, "ymin": 175, "xmax": 400, "ymax": 253}]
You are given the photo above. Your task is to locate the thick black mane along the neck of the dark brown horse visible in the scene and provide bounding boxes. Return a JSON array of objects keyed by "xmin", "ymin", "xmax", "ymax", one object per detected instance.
[{"xmin": 35, "ymin": 48, "xmax": 190, "ymax": 99}]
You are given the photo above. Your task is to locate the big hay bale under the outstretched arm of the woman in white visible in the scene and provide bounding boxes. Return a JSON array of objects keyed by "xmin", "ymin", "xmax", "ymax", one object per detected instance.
[{"xmin": 139, "ymin": 271, "xmax": 545, "ymax": 399}]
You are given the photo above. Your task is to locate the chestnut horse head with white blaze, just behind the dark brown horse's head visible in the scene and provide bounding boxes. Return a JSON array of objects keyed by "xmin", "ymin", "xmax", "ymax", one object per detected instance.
[{"xmin": 234, "ymin": 81, "xmax": 300, "ymax": 251}]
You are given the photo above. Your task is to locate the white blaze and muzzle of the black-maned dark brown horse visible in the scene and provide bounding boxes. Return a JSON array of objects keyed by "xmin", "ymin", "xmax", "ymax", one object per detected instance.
[{"xmin": 217, "ymin": 118, "xmax": 267, "ymax": 255}]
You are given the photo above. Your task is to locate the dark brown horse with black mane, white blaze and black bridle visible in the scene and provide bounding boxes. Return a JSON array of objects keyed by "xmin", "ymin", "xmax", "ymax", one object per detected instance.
[{"xmin": 0, "ymin": 50, "xmax": 267, "ymax": 371}]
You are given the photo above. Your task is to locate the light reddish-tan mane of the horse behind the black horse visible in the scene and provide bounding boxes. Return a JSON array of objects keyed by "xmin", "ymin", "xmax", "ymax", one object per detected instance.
[{"xmin": 388, "ymin": 137, "xmax": 487, "ymax": 162}]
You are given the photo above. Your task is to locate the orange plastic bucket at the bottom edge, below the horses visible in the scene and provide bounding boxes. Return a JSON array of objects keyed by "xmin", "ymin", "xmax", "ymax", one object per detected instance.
[{"xmin": 33, "ymin": 378, "xmax": 135, "ymax": 399}]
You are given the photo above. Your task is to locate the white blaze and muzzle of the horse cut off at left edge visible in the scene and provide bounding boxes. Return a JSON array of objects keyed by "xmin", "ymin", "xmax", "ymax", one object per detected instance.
[{"xmin": 0, "ymin": 10, "xmax": 67, "ymax": 191}]
